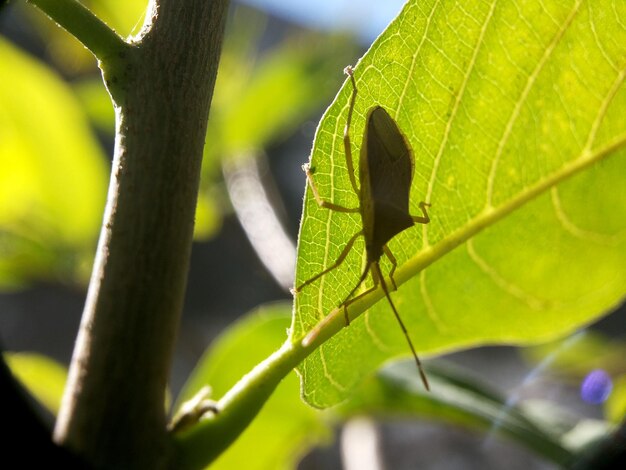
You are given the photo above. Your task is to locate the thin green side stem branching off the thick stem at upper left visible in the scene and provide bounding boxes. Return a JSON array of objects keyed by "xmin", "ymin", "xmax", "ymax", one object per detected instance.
[{"xmin": 26, "ymin": 0, "xmax": 128, "ymax": 61}]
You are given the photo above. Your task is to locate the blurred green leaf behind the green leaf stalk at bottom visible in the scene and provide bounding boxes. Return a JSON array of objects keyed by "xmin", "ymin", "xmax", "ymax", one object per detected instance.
[{"xmin": 171, "ymin": 304, "xmax": 330, "ymax": 470}]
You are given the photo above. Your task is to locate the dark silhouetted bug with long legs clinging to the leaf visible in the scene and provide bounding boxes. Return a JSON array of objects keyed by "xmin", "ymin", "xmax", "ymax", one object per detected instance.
[{"xmin": 295, "ymin": 66, "xmax": 430, "ymax": 390}]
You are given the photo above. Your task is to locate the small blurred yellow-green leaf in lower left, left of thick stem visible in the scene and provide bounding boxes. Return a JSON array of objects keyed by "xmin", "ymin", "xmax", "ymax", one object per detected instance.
[{"xmin": 4, "ymin": 353, "xmax": 67, "ymax": 415}]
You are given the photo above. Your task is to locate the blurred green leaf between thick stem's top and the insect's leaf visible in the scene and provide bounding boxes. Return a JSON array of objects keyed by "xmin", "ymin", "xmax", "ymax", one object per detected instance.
[{"xmin": 207, "ymin": 31, "xmax": 349, "ymax": 157}]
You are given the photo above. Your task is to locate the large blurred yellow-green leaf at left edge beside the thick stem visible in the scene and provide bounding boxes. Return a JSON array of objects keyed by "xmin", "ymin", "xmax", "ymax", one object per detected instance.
[{"xmin": 0, "ymin": 39, "xmax": 108, "ymax": 286}]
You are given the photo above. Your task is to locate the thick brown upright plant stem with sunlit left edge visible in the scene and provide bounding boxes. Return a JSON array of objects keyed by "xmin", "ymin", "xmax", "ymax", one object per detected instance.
[{"xmin": 50, "ymin": 0, "xmax": 228, "ymax": 469}]
